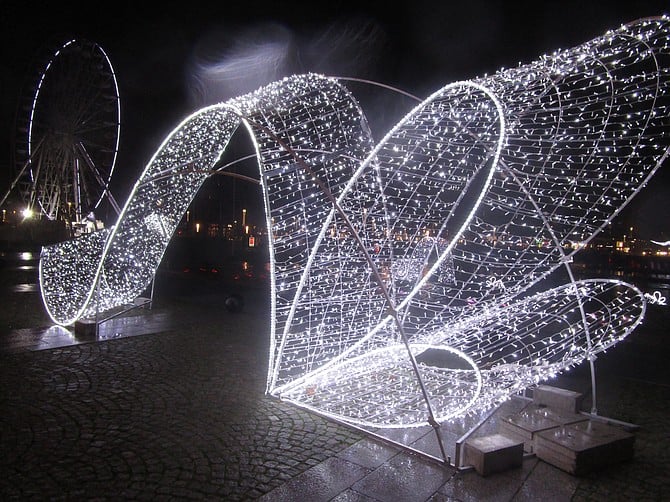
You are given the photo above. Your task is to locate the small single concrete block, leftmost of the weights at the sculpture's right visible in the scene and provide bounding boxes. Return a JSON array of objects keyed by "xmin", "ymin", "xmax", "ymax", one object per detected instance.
[{"xmin": 463, "ymin": 434, "xmax": 523, "ymax": 476}]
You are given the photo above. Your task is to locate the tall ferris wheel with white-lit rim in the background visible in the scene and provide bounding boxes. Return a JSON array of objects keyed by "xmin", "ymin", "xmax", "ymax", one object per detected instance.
[{"xmin": 3, "ymin": 40, "xmax": 121, "ymax": 223}]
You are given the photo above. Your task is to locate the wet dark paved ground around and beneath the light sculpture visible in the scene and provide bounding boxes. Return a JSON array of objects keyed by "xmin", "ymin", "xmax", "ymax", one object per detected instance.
[{"xmin": 0, "ymin": 249, "xmax": 670, "ymax": 501}]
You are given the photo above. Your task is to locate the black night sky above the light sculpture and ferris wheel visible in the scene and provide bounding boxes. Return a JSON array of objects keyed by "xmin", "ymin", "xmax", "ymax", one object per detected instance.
[{"xmin": 0, "ymin": 0, "xmax": 670, "ymax": 239}]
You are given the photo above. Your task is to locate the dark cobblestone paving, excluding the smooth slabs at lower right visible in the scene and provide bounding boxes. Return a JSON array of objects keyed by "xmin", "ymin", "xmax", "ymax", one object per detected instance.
[{"xmin": 0, "ymin": 253, "xmax": 361, "ymax": 500}]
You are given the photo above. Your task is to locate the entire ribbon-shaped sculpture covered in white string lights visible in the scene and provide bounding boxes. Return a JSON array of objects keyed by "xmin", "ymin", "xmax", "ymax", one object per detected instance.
[{"xmin": 40, "ymin": 17, "xmax": 670, "ymax": 436}]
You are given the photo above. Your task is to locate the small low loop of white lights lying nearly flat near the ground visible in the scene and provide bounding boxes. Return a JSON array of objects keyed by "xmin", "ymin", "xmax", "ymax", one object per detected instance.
[{"xmin": 281, "ymin": 344, "xmax": 483, "ymax": 428}]
